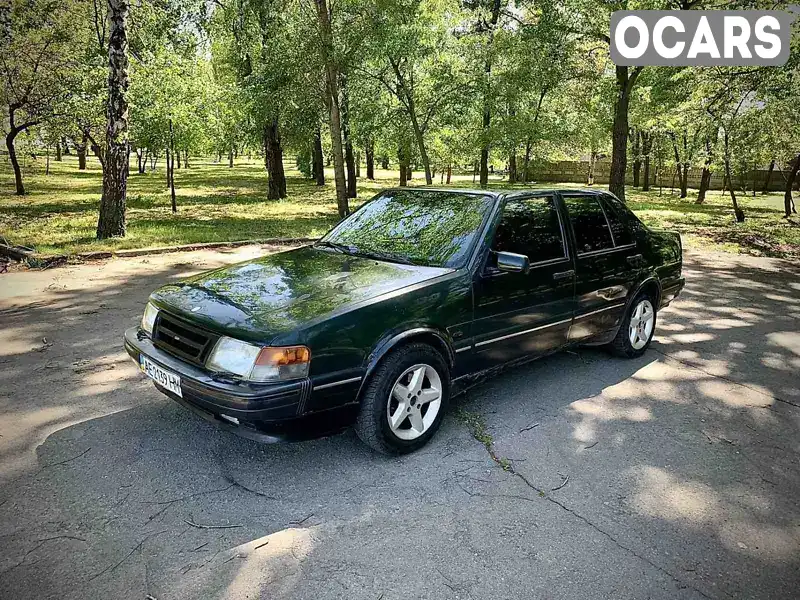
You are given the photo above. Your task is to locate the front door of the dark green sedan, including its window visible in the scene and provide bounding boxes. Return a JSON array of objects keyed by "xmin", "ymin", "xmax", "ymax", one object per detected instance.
[{"xmin": 471, "ymin": 194, "xmax": 575, "ymax": 370}]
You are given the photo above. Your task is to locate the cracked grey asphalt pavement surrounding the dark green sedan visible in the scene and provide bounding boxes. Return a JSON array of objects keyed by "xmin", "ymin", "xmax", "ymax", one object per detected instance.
[{"xmin": 0, "ymin": 247, "xmax": 800, "ymax": 600}]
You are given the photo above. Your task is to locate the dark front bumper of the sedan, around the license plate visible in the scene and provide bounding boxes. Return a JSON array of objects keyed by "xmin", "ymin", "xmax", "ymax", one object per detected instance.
[{"xmin": 125, "ymin": 327, "xmax": 311, "ymax": 442}]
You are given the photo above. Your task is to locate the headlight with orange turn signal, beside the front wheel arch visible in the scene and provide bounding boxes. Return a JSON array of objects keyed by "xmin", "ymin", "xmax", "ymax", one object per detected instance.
[{"xmin": 206, "ymin": 337, "xmax": 311, "ymax": 381}]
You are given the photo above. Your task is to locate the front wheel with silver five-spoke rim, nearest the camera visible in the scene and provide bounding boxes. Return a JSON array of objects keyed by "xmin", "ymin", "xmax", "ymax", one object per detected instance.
[{"xmin": 355, "ymin": 343, "xmax": 450, "ymax": 454}]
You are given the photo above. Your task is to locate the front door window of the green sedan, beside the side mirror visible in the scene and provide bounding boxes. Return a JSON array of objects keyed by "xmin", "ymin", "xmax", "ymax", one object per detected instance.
[{"xmin": 490, "ymin": 196, "xmax": 566, "ymax": 264}]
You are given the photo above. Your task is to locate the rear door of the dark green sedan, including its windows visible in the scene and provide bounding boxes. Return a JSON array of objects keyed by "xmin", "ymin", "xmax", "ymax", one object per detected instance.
[{"xmin": 562, "ymin": 192, "xmax": 643, "ymax": 341}]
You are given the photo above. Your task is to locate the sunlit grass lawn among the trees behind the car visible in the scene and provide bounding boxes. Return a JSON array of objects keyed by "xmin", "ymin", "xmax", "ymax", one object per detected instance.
[{"xmin": 0, "ymin": 156, "xmax": 800, "ymax": 257}]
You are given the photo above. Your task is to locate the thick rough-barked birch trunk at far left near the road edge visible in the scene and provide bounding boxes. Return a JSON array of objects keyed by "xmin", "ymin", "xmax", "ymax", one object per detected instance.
[{"xmin": 97, "ymin": 0, "xmax": 128, "ymax": 239}]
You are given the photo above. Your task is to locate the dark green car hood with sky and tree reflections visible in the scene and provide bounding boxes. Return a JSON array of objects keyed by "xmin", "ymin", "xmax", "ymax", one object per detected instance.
[{"xmin": 151, "ymin": 246, "xmax": 452, "ymax": 342}]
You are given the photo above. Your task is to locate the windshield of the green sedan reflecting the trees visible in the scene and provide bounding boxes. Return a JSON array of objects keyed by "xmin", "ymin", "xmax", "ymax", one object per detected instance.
[{"xmin": 317, "ymin": 190, "xmax": 494, "ymax": 268}]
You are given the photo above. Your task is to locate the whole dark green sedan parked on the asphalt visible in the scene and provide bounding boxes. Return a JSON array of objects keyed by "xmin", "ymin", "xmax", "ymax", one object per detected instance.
[{"xmin": 125, "ymin": 188, "xmax": 684, "ymax": 453}]
